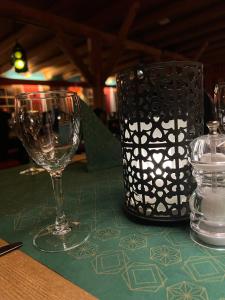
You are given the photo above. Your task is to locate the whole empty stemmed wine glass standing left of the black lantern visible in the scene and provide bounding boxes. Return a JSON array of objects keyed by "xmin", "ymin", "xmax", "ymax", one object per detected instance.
[{"xmin": 15, "ymin": 90, "xmax": 88, "ymax": 252}]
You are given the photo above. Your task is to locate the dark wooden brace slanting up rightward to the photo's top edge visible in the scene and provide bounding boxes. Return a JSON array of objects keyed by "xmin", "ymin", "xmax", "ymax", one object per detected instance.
[{"xmin": 103, "ymin": 1, "xmax": 140, "ymax": 81}]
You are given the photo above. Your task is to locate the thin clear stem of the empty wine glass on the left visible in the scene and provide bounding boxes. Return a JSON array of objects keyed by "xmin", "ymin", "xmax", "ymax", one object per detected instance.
[{"xmin": 50, "ymin": 172, "xmax": 71, "ymax": 235}]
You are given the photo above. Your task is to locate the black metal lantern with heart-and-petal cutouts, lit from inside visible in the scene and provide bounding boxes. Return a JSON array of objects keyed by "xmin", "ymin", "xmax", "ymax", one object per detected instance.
[{"xmin": 117, "ymin": 62, "xmax": 203, "ymax": 222}]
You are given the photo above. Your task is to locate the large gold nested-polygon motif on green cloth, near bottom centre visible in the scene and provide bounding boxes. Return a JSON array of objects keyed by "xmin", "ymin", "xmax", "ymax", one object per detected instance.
[{"xmin": 122, "ymin": 262, "xmax": 166, "ymax": 293}]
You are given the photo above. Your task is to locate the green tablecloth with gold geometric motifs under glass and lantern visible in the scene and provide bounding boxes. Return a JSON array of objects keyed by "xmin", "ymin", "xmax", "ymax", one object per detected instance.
[{"xmin": 0, "ymin": 163, "xmax": 225, "ymax": 300}]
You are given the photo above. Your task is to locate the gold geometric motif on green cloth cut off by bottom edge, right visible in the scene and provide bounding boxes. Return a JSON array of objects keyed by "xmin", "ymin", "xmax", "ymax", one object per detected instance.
[{"xmin": 167, "ymin": 281, "xmax": 209, "ymax": 300}]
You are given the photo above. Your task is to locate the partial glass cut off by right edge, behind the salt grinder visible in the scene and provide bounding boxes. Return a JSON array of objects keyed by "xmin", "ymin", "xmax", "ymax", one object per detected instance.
[{"xmin": 214, "ymin": 82, "xmax": 225, "ymax": 133}]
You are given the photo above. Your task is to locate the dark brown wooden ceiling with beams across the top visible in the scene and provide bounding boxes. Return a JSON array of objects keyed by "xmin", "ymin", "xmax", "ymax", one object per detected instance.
[{"xmin": 0, "ymin": 0, "xmax": 225, "ymax": 84}]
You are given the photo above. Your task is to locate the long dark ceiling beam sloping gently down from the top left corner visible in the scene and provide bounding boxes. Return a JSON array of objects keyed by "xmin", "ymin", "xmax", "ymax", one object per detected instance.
[{"xmin": 0, "ymin": 0, "xmax": 188, "ymax": 62}]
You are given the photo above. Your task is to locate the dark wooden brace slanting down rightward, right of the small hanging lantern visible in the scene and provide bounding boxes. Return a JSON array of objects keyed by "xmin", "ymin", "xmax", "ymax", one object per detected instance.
[{"xmin": 56, "ymin": 31, "xmax": 94, "ymax": 84}]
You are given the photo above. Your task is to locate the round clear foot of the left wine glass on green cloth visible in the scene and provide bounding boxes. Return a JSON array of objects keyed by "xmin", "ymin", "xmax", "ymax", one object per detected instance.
[{"xmin": 33, "ymin": 222, "xmax": 89, "ymax": 252}]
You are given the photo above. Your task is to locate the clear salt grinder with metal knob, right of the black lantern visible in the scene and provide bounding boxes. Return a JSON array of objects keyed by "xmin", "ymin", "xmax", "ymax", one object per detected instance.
[{"xmin": 189, "ymin": 121, "xmax": 225, "ymax": 250}]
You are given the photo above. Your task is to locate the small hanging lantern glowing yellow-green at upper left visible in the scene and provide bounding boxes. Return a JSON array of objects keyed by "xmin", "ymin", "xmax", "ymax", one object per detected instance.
[{"xmin": 11, "ymin": 43, "xmax": 28, "ymax": 73}]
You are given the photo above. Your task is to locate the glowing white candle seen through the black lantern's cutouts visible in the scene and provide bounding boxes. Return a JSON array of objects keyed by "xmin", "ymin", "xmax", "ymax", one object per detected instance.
[{"xmin": 124, "ymin": 117, "xmax": 189, "ymax": 215}]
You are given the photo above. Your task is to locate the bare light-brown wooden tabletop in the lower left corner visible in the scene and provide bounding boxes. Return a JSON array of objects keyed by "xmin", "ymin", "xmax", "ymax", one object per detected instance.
[{"xmin": 0, "ymin": 240, "xmax": 97, "ymax": 300}]
